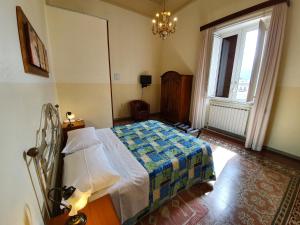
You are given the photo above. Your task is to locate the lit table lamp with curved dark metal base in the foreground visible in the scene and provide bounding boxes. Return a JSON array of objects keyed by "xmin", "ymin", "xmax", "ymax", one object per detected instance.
[{"xmin": 48, "ymin": 186, "xmax": 91, "ymax": 225}]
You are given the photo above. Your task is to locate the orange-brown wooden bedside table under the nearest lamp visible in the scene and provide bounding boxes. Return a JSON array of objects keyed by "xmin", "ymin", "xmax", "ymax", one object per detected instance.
[{"xmin": 47, "ymin": 195, "xmax": 121, "ymax": 225}]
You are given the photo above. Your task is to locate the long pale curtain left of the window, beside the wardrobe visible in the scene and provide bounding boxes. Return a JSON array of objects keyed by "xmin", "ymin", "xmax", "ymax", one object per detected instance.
[{"xmin": 191, "ymin": 28, "xmax": 213, "ymax": 128}]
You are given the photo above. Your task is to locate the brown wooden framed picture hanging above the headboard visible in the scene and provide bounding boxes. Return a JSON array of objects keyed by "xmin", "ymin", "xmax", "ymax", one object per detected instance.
[{"xmin": 16, "ymin": 6, "xmax": 49, "ymax": 77}]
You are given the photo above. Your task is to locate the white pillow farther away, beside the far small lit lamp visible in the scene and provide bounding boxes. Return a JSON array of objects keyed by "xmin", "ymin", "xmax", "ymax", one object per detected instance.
[{"xmin": 62, "ymin": 127, "xmax": 101, "ymax": 154}]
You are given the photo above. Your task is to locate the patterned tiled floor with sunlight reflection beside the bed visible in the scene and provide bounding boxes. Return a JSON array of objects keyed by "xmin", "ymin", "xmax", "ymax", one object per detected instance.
[{"xmin": 115, "ymin": 118, "xmax": 300, "ymax": 225}]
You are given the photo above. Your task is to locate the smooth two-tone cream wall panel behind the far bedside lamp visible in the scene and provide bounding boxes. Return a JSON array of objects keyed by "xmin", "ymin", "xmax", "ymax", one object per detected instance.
[{"xmin": 46, "ymin": 6, "xmax": 112, "ymax": 128}]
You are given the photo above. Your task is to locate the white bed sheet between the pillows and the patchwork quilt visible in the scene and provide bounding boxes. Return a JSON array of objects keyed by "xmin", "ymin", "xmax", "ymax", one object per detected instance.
[{"xmin": 89, "ymin": 128, "xmax": 149, "ymax": 223}]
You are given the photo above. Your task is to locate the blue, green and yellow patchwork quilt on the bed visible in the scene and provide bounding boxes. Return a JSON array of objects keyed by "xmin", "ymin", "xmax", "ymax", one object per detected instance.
[{"xmin": 112, "ymin": 120, "xmax": 215, "ymax": 209}]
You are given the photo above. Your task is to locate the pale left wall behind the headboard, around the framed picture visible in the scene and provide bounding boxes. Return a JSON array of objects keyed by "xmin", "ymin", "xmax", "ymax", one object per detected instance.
[{"xmin": 0, "ymin": 0, "xmax": 57, "ymax": 225}]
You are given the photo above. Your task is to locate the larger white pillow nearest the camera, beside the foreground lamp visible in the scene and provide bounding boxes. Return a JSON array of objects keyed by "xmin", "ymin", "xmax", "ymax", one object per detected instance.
[{"xmin": 64, "ymin": 144, "xmax": 120, "ymax": 193}]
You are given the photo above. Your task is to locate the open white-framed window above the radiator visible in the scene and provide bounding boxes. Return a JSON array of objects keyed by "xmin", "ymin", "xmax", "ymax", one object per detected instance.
[{"xmin": 208, "ymin": 17, "xmax": 268, "ymax": 102}]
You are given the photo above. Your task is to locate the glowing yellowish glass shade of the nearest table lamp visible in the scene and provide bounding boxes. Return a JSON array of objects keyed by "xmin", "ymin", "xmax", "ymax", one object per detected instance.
[{"xmin": 66, "ymin": 189, "xmax": 91, "ymax": 216}]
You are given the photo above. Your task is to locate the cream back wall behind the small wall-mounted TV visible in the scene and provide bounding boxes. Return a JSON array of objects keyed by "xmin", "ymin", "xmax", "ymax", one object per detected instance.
[{"xmin": 47, "ymin": 0, "xmax": 162, "ymax": 118}]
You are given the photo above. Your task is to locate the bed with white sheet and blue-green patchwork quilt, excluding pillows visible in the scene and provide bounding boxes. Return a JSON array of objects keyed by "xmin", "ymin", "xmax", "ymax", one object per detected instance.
[{"xmin": 90, "ymin": 120, "xmax": 215, "ymax": 224}]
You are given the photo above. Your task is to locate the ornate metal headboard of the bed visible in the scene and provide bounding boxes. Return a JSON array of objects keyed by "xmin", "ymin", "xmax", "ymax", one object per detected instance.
[{"xmin": 24, "ymin": 103, "xmax": 63, "ymax": 220}]
